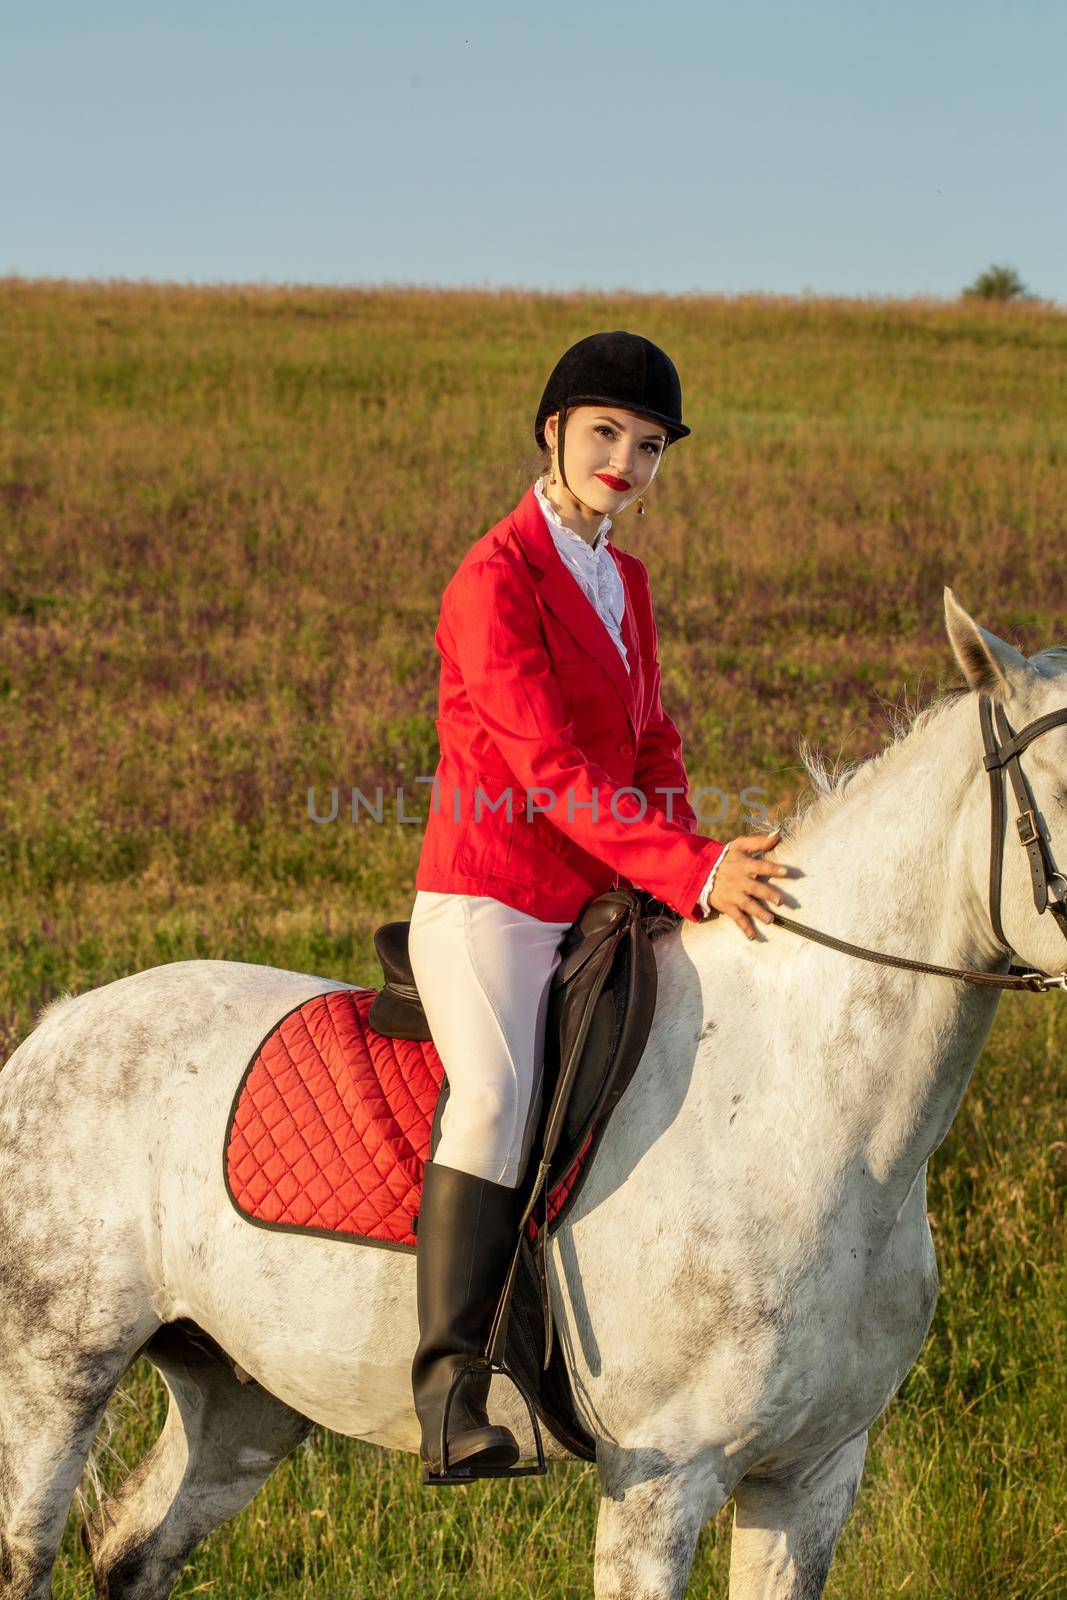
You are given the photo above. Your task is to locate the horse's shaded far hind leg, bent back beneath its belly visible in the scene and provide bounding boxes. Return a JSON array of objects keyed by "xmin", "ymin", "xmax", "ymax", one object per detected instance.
[{"xmin": 85, "ymin": 1323, "xmax": 314, "ymax": 1600}]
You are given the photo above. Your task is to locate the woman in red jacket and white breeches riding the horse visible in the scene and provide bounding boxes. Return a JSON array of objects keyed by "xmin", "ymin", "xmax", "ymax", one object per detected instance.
[{"xmin": 408, "ymin": 331, "xmax": 785, "ymax": 1482}]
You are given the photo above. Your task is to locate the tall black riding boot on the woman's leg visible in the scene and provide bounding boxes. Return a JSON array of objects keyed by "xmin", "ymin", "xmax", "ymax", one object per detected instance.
[{"xmin": 411, "ymin": 1162, "xmax": 518, "ymax": 1478}]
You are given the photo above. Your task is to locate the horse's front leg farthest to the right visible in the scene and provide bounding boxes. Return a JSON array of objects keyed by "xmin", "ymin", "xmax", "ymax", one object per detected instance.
[{"xmin": 729, "ymin": 1432, "xmax": 867, "ymax": 1600}]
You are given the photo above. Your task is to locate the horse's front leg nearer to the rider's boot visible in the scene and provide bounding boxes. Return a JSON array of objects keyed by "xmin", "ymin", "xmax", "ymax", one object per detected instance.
[{"xmin": 593, "ymin": 1443, "xmax": 726, "ymax": 1600}]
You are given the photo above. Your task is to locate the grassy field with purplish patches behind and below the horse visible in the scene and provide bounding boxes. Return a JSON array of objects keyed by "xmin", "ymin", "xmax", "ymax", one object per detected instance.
[{"xmin": 0, "ymin": 280, "xmax": 1067, "ymax": 1600}]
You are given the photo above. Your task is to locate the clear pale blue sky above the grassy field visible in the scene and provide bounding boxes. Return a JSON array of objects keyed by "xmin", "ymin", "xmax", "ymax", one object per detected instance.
[{"xmin": 0, "ymin": 0, "xmax": 1067, "ymax": 301}]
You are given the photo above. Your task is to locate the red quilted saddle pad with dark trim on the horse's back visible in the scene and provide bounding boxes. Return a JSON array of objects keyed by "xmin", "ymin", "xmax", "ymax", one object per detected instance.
[{"xmin": 222, "ymin": 989, "xmax": 592, "ymax": 1250}]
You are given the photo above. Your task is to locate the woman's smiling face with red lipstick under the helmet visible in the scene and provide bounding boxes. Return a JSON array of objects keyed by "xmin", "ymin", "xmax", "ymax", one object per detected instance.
[{"xmin": 544, "ymin": 405, "xmax": 667, "ymax": 515}]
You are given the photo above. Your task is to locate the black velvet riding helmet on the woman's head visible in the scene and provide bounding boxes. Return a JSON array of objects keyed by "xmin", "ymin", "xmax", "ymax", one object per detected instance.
[{"xmin": 534, "ymin": 328, "xmax": 691, "ymax": 512}]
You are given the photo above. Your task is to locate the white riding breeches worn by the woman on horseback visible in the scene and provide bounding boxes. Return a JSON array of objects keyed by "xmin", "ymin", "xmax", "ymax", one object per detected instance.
[{"xmin": 408, "ymin": 890, "xmax": 571, "ymax": 1189}]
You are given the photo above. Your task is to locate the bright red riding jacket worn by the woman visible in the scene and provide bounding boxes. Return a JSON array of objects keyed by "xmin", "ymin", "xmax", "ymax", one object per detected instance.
[{"xmin": 414, "ymin": 488, "xmax": 726, "ymax": 922}]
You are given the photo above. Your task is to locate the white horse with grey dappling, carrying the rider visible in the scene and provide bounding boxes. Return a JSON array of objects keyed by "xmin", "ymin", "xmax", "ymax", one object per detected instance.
[{"xmin": 0, "ymin": 590, "xmax": 1067, "ymax": 1600}]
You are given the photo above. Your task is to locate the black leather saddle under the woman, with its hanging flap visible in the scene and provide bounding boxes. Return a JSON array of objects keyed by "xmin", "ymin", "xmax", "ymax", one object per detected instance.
[{"xmin": 368, "ymin": 888, "xmax": 668, "ymax": 1470}]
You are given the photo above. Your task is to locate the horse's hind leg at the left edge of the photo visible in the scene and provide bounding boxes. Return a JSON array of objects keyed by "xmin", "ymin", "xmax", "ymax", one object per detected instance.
[{"xmin": 0, "ymin": 1320, "xmax": 136, "ymax": 1600}]
